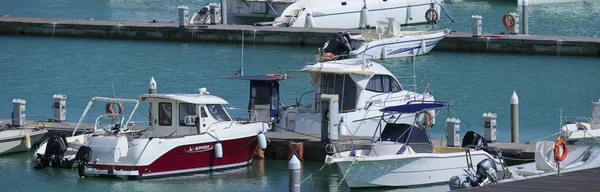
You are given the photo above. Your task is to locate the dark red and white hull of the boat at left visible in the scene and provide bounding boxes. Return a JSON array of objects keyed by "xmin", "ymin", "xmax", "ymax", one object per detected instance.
[{"xmin": 85, "ymin": 136, "xmax": 258, "ymax": 179}]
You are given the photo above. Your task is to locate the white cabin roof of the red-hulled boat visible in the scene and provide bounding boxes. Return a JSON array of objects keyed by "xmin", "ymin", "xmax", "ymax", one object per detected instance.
[{"xmin": 140, "ymin": 94, "xmax": 229, "ymax": 104}]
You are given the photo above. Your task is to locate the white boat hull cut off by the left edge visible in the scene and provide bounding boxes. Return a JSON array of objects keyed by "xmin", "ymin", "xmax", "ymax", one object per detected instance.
[{"xmin": 0, "ymin": 129, "xmax": 48, "ymax": 154}]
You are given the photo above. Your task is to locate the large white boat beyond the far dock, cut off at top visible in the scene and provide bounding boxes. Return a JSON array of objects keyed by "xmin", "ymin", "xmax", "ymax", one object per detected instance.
[{"xmin": 272, "ymin": 0, "xmax": 440, "ymax": 29}]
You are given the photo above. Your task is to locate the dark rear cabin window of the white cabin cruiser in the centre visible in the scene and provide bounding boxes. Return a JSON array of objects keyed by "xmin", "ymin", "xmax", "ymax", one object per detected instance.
[{"xmin": 321, "ymin": 74, "xmax": 356, "ymax": 111}]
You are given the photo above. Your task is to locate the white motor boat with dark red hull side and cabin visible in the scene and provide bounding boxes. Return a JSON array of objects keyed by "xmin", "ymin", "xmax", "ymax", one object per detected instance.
[{"xmin": 78, "ymin": 88, "xmax": 270, "ymax": 179}]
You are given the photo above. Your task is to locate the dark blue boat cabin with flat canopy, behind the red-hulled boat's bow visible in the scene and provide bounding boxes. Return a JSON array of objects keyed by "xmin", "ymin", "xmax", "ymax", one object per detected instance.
[{"xmin": 221, "ymin": 74, "xmax": 297, "ymax": 122}]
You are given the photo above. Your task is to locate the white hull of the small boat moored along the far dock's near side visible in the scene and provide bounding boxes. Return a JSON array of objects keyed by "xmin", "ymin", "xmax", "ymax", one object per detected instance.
[{"xmin": 350, "ymin": 31, "xmax": 445, "ymax": 59}]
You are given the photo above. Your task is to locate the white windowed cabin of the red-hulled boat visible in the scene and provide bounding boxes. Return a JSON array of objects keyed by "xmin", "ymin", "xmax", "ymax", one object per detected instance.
[{"xmin": 140, "ymin": 88, "xmax": 231, "ymax": 137}]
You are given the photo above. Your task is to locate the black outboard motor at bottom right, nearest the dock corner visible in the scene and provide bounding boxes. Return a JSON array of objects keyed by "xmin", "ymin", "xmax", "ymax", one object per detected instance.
[{"xmin": 449, "ymin": 158, "xmax": 498, "ymax": 190}]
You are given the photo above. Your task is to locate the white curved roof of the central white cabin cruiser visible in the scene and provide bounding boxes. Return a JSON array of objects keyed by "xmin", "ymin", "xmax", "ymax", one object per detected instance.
[{"xmin": 289, "ymin": 58, "xmax": 392, "ymax": 75}]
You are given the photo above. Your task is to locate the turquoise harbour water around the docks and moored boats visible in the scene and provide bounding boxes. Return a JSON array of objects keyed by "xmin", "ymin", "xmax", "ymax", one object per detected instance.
[{"xmin": 0, "ymin": 0, "xmax": 600, "ymax": 191}]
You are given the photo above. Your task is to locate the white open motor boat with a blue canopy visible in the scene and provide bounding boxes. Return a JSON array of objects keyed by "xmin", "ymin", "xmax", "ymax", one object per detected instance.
[{"xmin": 325, "ymin": 102, "xmax": 505, "ymax": 188}]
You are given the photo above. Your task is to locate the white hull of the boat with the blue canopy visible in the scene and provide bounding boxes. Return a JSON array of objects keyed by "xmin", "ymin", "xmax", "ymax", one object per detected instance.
[{"xmin": 334, "ymin": 151, "xmax": 492, "ymax": 190}]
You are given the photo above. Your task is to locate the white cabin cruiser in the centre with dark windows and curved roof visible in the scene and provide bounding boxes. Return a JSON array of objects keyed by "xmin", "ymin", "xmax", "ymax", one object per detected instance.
[{"xmin": 275, "ymin": 58, "xmax": 435, "ymax": 137}]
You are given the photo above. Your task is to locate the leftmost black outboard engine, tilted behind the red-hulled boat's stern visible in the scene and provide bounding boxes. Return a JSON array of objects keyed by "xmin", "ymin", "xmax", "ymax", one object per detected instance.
[{"xmin": 34, "ymin": 134, "xmax": 67, "ymax": 169}]
